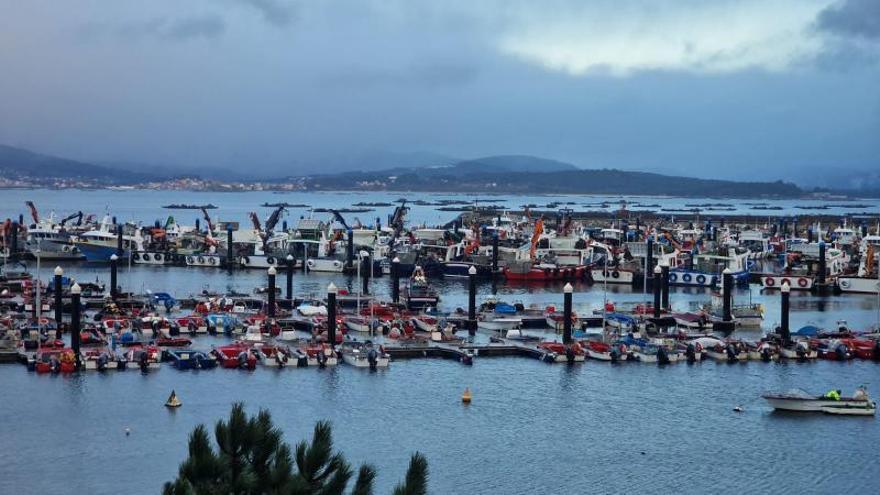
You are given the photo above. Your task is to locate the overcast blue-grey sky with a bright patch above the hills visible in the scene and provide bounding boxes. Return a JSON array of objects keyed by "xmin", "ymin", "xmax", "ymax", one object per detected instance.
[{"xmin": 0, "ymin": 0, "xmax": 880, "ymax": 182}]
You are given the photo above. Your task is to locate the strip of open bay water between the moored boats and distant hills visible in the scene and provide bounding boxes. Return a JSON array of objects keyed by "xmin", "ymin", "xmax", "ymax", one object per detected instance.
[{"xmin": 0, "ymin": 189, "xmax": 880, "ymax": 226}]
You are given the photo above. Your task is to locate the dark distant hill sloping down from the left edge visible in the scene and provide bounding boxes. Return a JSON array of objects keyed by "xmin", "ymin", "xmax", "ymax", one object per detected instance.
[{"xmin": 0, "ymin": 145, "xmax": 156, "ymax": 183}]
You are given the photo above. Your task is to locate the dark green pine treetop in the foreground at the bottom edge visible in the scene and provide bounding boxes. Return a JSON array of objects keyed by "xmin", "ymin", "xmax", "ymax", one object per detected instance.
[{"xmin": 163, "ymin": 403, "xmax": 428, "ymax": 495}]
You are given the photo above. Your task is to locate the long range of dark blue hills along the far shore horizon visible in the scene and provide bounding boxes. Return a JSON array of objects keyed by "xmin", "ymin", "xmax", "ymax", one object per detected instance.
[{"xmin": 0, "ymin": 141, "xmax": 880, "ymax": 197}]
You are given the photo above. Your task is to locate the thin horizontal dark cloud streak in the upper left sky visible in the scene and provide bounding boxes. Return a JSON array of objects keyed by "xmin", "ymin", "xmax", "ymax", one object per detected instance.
[{"xmin": 79, "ymin": 15, "xmax": 226, "ymax": 41}]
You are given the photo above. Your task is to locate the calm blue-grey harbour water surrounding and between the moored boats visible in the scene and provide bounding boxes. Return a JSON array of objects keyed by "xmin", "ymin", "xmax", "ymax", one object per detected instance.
[{"xmin": 0, "ymin": 191, "xmax": 880, "ymax": 494}]
